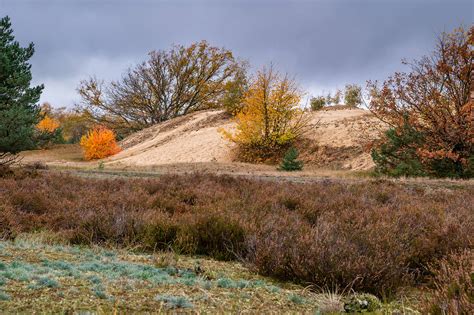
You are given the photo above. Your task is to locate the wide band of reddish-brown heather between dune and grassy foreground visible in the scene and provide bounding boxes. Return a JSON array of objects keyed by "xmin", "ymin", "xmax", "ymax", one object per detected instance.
[{"xmin": 0, "ymin": 172, "xmax": 474, "ymax": 296}]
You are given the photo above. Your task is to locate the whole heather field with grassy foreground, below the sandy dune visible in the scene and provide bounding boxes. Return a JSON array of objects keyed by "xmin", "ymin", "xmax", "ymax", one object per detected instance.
[{"xmin": 0, "ymin": 170, "xmax": 474, "ymax": 313}]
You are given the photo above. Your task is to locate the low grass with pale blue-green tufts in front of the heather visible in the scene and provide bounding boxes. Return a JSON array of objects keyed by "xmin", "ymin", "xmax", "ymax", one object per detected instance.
[{"xmin": 0, "ymin": 234, "xmax": 411, "ymax": 313}]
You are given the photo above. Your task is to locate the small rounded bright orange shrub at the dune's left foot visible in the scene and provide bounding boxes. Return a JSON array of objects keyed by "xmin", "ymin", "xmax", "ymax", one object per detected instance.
[{"xmin": 80, "ymin": 126, "xmax": 120, "ymax": 160}]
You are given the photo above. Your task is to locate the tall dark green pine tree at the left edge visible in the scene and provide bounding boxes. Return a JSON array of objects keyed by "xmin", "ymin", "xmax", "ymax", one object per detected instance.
[{"xmin": 0, "ymin": 16, "xmax": 43, "ymax": 165}]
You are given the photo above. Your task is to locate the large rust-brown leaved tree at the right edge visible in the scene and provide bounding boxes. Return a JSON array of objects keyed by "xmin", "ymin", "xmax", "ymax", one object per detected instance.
[{"xmin": 369, "ymin": 27, "xmax": 474, "ymax": 177}]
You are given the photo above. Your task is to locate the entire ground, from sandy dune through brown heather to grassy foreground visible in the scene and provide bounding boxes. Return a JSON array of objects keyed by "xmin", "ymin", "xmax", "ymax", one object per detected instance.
[{"xmin": 4, "ymin": 109, "xmax": 474, "ymax": 314}]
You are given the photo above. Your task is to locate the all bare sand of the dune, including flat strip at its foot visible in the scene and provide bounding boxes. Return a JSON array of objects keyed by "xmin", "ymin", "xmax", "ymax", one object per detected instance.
[{"xmin": 22, "ymin": 109, "xmax": 381, "ymax": 176}]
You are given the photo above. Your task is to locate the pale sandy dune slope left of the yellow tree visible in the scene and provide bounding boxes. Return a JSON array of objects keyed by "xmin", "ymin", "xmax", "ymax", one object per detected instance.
[{"xmin": 106, "ymin": 111, "xmax": 233, "ymax": 166}]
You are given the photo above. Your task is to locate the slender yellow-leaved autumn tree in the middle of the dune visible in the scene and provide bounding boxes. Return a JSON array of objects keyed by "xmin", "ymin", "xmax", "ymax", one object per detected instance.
[{"xmin": 222, "ymin": 66, "xmax": 307, "ymax": 160}]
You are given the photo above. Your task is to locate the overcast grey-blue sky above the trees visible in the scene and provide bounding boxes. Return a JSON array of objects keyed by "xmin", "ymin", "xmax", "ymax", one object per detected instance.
[{"xmin": 0, "ymin": 0, "xmax": 474, "ymax": 106}]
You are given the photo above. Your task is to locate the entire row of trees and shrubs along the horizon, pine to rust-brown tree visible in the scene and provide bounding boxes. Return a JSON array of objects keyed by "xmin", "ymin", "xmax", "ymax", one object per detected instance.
[{"xmin": 0, "ymin": 17, "xmax": 474, "ymax": 178}]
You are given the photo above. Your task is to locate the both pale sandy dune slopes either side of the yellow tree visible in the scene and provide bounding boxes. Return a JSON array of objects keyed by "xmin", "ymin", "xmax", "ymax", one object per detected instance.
[{"xmin": 106, "ymin": 109, "xmax": 377, "ymax": 170}]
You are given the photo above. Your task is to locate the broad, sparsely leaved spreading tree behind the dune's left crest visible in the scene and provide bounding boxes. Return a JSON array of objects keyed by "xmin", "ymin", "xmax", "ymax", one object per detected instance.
[{"xmin": 78, "ymin": 41, "xmax": 245, "ymax": 134}]
